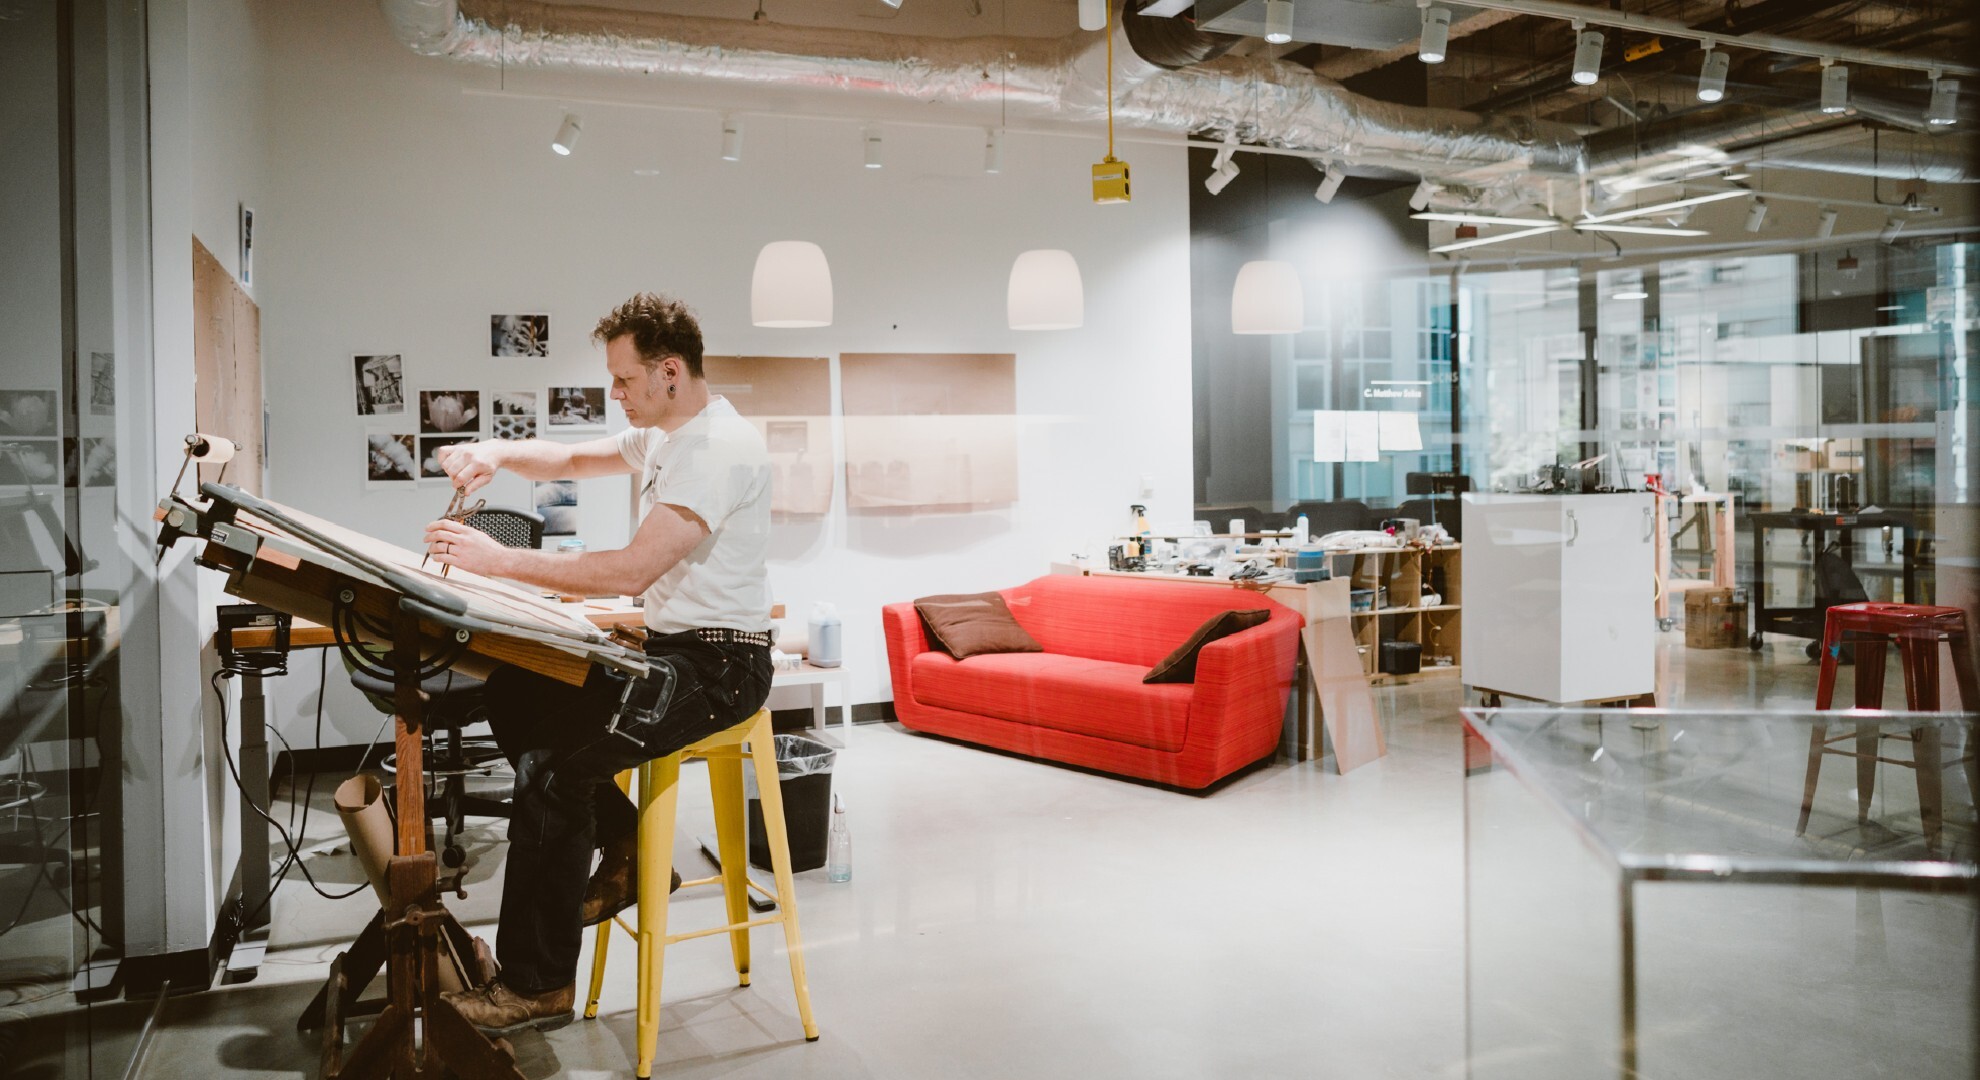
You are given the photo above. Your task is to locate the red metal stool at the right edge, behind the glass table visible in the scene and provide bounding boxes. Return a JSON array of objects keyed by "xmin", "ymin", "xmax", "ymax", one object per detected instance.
[{"xmin": 1794, "ymin": 602, "xmax": 1980, "ymax": 850}]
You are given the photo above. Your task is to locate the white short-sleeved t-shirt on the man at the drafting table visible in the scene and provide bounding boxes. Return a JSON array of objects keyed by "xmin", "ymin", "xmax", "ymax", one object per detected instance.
[{"xmin": 616, "ymin": 396, "xmax": 770, "ymax": 634}]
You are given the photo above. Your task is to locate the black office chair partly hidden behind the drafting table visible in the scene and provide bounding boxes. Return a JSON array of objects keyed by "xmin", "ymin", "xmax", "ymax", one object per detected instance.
[{"xmin": 350, "ymin": 507, "xmax": 543, "ymax": 870}]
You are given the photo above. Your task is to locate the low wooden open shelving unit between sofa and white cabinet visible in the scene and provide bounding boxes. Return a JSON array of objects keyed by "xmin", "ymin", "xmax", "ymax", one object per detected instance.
[{"xmin": 1327, "ymin": 543, "xmax": 1463, "ymax": 682}]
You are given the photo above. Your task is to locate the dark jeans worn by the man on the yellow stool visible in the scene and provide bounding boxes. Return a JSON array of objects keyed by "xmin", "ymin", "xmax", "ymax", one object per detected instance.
[{"xmin": 485, "ymin": 634, "xmax": 770, "ymax": 995}]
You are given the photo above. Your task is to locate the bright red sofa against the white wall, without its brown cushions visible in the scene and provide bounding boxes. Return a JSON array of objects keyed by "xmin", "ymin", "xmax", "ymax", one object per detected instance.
[{"xmin": 881, "ymin": 575, "xmax": 1301, "ymax": 789}]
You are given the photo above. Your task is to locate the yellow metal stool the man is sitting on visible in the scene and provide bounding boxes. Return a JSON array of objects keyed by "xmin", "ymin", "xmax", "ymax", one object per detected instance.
[{"xmin": 584, "ymin": 709, "xmax": 818, "ymax": 1080}]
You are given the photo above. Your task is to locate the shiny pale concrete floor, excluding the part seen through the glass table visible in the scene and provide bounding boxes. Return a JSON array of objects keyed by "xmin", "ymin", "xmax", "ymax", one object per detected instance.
[{"xmin": 0, "ymin": 634, "xmax": 1974, "ymax": 1080}]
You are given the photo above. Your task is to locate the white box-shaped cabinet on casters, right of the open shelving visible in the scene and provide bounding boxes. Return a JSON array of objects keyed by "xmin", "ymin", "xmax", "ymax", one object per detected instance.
[{"xmin": 1463, "ymin": 491, "xmax": 1657, "ymax": 702}]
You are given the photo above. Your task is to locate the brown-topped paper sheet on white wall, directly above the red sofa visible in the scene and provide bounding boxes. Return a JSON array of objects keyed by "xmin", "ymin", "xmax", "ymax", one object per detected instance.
[{"xmin": 840, "ymin": 353, "xmax": 1018, "ymax": 509}]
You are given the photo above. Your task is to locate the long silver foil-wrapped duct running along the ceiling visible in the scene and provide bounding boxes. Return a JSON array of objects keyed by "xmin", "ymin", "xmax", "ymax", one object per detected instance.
[{"xmin": 380, "ymin": 0, "xmax": 1970, "ymax": 204}]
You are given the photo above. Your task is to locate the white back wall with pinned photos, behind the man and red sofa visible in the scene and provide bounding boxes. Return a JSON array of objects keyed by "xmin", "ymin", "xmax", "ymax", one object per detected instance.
[{"xmin": 255, "ymin": 2, "xmax": 1190, "ymax": 743}]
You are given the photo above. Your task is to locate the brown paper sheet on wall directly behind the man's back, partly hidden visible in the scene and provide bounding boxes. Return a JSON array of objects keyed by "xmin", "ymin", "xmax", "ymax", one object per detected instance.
[{"xmin": 701, "ymin": 357, "xmax": 838, "ymax": 517}]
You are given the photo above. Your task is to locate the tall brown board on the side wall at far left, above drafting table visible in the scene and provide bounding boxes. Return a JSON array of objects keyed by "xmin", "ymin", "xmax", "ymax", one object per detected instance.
[{"xmin": 192, "ymin": 238, "xmax": 263, "ymax": 495}]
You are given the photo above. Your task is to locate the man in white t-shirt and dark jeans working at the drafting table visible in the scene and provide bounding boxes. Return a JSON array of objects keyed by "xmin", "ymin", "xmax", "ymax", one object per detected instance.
[{"xmin": 426, "ymin": 293, "xmax": 770, "ymax": 1034}]
